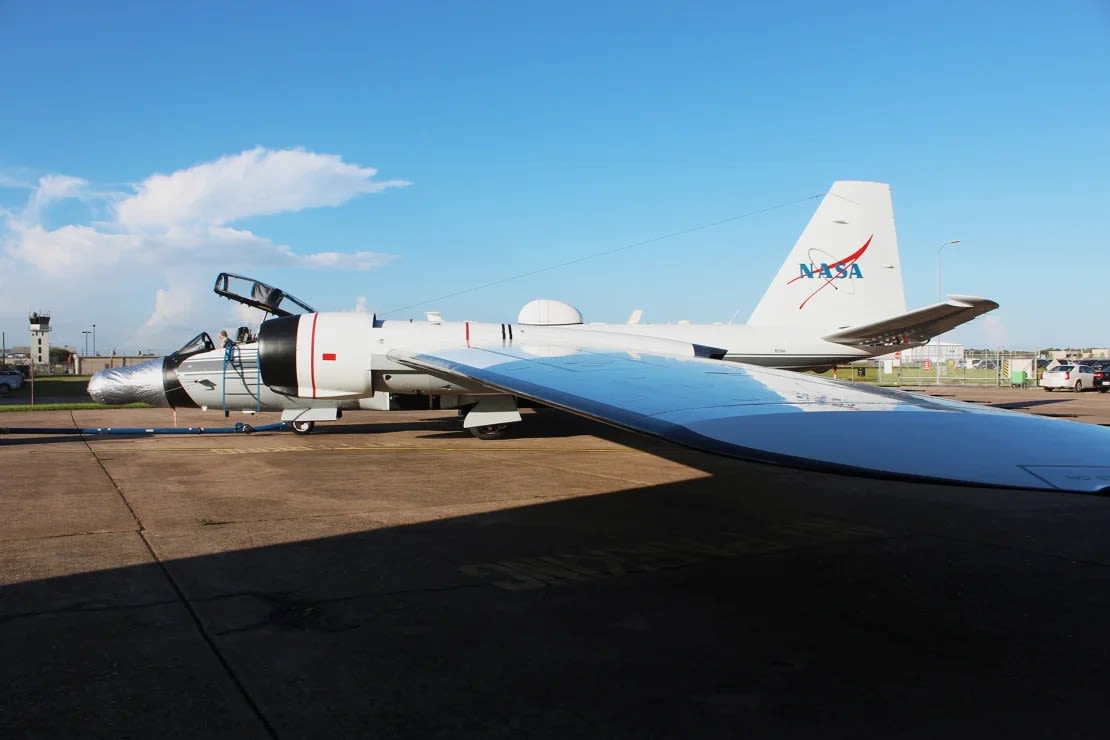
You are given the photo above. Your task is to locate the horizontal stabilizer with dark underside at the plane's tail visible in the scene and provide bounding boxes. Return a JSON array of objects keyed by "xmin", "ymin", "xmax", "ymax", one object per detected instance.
[{"xmin": 821, "ymin": 295, "xmax": 998, "ymax": 347}]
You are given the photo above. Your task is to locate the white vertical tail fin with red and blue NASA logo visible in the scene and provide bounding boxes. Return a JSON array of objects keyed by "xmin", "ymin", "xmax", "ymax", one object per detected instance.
[{"xmin": 748, "ymin": 180, "xmax": 906, "ymax": 330}]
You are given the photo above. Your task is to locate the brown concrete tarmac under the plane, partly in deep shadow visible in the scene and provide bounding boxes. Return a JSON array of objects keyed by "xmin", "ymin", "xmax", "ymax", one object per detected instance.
[{"xmin": 0, "ymin": 387, "xmax": 1110, "ymax": 738}]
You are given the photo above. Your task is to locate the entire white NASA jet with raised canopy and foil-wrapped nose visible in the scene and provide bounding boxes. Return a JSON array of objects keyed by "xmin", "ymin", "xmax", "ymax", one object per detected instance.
[{"xmin": 89, "ymin": 183, "xmax": 1110, "ymax": 493}]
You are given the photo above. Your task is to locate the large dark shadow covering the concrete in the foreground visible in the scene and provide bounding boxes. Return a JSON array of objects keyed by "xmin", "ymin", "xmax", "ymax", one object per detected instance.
[{"xmin": 0, "ymin": 418, "xmax": 1110, "ymax": 738}]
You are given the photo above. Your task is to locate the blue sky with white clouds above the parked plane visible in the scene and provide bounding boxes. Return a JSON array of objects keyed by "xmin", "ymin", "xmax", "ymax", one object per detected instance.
[{"xmin": 0, "ymin": 0, "xmax": 1110, "ymax": 352}]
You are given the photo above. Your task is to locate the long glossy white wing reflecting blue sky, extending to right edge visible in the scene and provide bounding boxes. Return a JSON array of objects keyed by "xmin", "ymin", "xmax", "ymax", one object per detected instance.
[{"xmin": 390, "ymin": 346, "xmax": 1110, "ymax": 493}]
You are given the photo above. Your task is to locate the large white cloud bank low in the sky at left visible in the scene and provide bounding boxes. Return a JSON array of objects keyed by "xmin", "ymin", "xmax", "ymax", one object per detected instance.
[{"xmin": 0, "ymin": 148, "xmax": 408, "ymax": 347}]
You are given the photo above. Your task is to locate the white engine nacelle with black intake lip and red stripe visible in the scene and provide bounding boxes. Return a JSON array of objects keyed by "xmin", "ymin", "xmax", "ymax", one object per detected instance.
[{"xmin": 259, "ymin": 313, "xmax": 375, "ymax": 398}]
